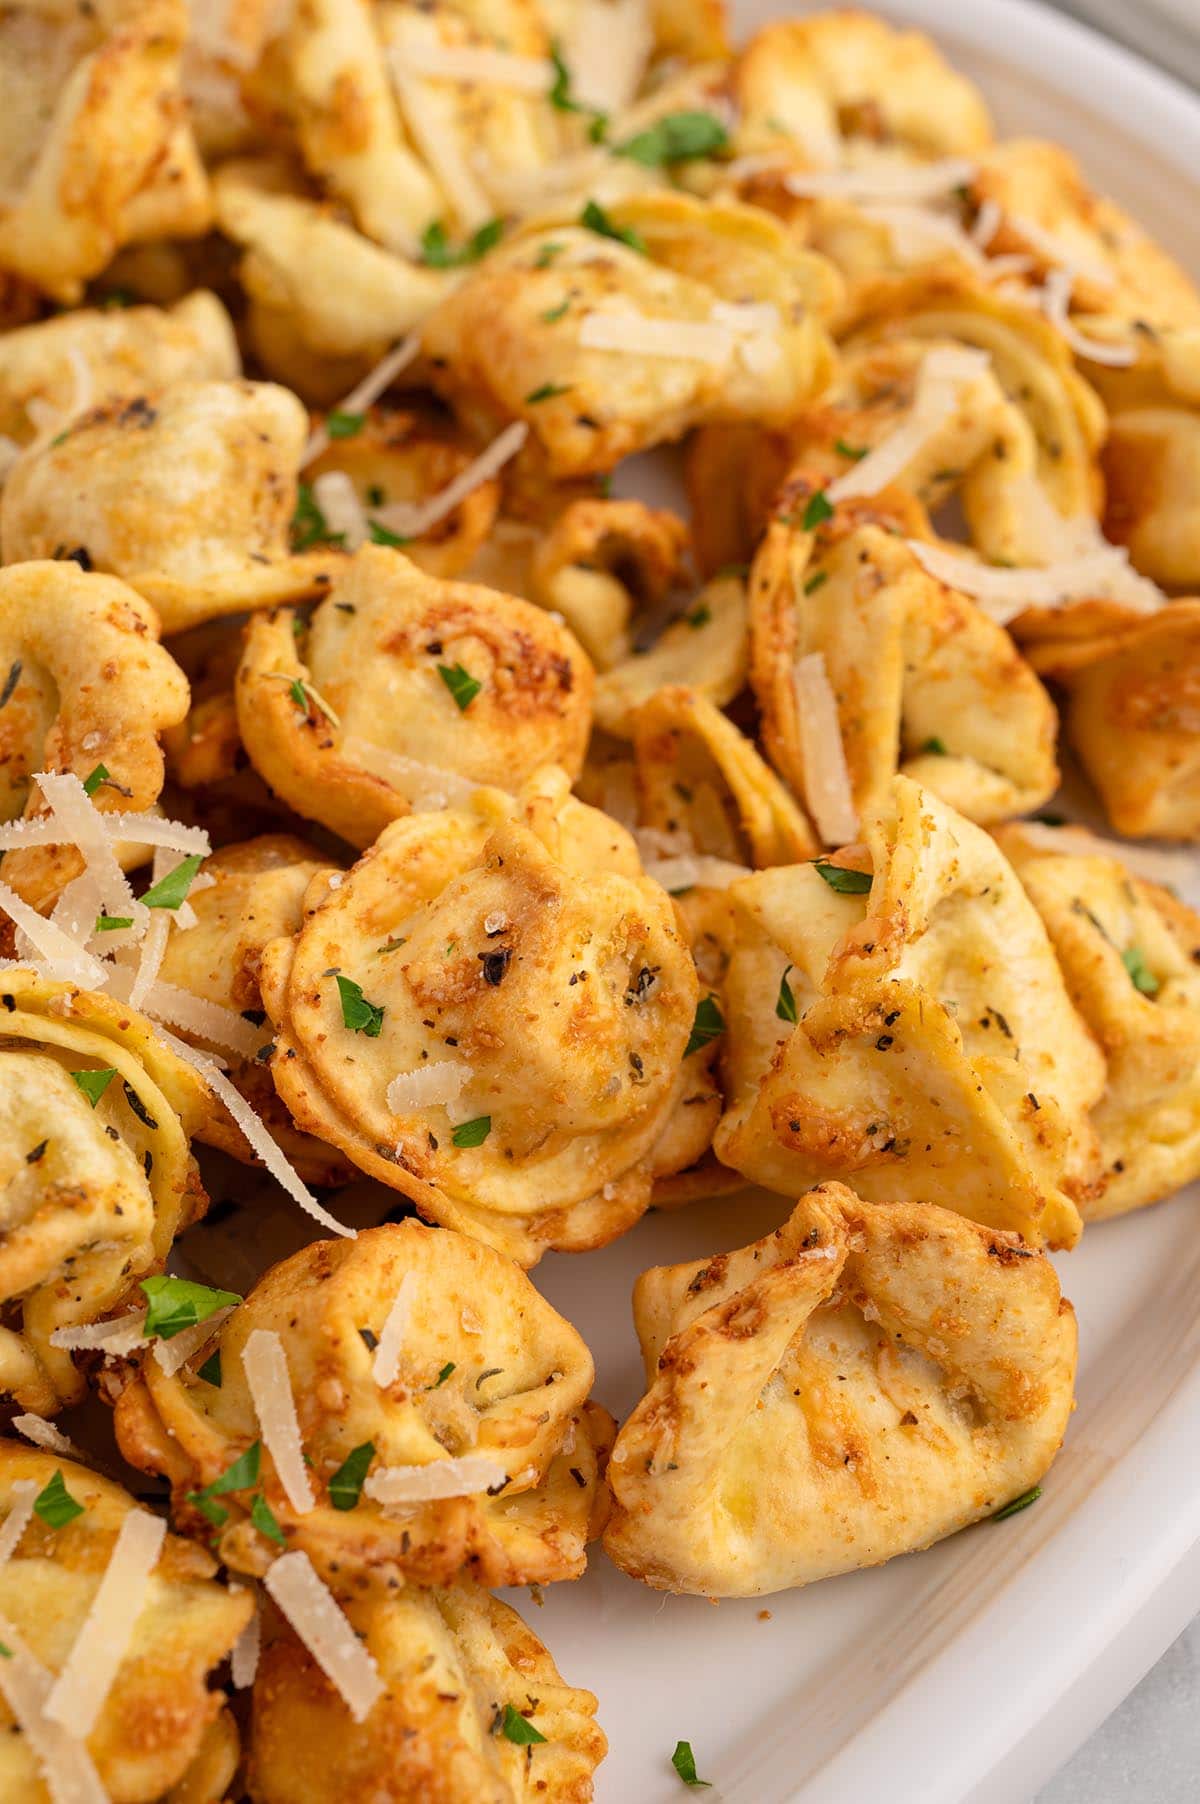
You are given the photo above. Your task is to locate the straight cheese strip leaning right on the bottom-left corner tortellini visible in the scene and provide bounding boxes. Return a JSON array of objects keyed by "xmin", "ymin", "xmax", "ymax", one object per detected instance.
[{"xmin": 45, "ymin": 1510, "xmax": 166, "ymax": 1741}]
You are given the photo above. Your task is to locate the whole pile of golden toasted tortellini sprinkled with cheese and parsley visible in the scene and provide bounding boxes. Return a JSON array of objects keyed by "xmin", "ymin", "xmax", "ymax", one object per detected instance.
[{"xmin": 0, "ymin": 0, "xmax": 1200, "ymax": 1804}]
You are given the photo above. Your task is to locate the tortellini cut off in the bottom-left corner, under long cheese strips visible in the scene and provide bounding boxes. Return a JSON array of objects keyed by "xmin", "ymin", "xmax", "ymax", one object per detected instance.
[{"xmin": 0, "ymin": 1441, "xmax": 254, "ymax": 1804}]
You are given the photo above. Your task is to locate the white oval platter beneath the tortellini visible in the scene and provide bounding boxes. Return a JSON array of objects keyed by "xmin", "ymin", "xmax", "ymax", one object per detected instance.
[{"xmin": 512, "ymin": 0, "xmax": 1200, "ymax": 1804}]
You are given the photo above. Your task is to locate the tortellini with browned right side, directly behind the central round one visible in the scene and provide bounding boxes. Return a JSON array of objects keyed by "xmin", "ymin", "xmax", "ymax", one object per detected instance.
[{"xmin": 236, "ymin": 545, "xmax": 592, "ymax": 846}]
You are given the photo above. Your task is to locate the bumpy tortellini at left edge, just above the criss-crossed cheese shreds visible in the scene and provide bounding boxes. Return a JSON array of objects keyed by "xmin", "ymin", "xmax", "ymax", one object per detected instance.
[{"xmin": 0, "ymin": 557, "xmax": 188, "ymax": 907}]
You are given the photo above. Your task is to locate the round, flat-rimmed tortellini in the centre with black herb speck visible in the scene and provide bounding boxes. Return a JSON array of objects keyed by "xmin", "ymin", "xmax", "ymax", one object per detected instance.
[{"xmin": 252, "ymin": 772, "xmax": 703, "ymax": 1265}]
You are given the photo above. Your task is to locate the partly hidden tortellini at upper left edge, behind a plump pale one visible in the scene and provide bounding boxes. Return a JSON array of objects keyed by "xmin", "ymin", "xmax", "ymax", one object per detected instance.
[{"xmin": 0, "ymin": 289, "xmax": 242, "ymax": 444}]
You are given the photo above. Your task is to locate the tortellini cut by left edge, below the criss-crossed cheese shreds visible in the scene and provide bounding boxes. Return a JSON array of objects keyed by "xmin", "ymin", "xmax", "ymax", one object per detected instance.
[{"xmin": 0, "ymin": 967, "xmax": 208, "ymax": 1414}]
